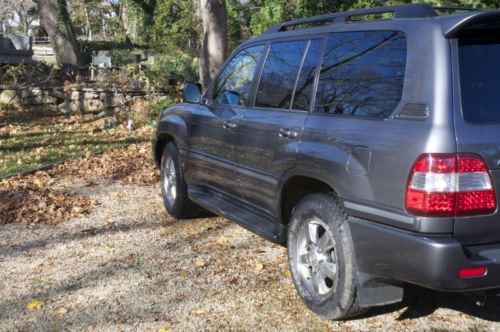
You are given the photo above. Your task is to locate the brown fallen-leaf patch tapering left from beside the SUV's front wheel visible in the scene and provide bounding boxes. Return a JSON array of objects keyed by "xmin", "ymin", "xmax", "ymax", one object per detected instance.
[{"xmin": 51, "ymin": 143, "xmax": 160, "ymax": 186}]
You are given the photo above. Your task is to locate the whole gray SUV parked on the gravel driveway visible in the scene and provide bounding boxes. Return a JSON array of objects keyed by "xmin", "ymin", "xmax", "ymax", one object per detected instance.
[{"xmin": 153, "ymin": 4, "xmax": 500, "ymax": 319}]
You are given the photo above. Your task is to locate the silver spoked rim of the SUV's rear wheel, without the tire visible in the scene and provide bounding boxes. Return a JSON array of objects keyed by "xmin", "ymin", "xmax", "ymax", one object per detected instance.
[{"xmin": 296, "ymin": 218, "xmax": 337, "ymax": 296}]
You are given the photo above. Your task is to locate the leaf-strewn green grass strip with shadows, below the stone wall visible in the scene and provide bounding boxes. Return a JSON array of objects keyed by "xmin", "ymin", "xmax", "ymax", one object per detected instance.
[{"xmin": 0, "ymin": 110, "xmax": 152, "ymax": 177}]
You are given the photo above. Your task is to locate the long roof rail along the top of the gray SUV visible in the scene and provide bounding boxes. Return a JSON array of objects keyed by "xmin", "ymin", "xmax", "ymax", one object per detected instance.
[{"xmin": 264, "ymin": 3, "xmax": 438, "ymax": 34}]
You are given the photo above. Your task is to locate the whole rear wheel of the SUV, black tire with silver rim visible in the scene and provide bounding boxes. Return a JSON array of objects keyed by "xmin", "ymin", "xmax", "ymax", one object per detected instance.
[{"xmin": 288, "ymin": 194, "xmax": 364, "ymax": 320}]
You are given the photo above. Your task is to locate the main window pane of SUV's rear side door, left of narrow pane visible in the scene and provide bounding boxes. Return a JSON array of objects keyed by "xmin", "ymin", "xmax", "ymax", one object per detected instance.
[{"xmin": 255, "ymin": 40, "xmax": 308, "ymax": 109}]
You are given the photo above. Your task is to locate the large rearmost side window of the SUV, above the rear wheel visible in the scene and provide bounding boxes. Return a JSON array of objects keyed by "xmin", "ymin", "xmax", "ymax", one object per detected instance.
[{"xmin": 314, "ymin": 31, "xmax": 406, "ymax": 118}]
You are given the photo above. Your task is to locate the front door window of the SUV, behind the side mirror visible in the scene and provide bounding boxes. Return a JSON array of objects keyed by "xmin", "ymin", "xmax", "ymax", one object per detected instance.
[{"xmin": 212, "ymin": 45, "xmax": 265, "ymax": 106}]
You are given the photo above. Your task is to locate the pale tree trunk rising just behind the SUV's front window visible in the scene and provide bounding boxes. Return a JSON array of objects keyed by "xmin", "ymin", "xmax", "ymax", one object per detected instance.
[{"xmin": 200, "ymin": 0, "xmax": 227, "ymax": 90}]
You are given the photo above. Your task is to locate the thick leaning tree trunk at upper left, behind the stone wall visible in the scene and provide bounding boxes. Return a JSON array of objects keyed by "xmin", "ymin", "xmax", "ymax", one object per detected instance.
[{"xmin": 36, "ymin": 0, "xmax": 83, "ymax": 74}]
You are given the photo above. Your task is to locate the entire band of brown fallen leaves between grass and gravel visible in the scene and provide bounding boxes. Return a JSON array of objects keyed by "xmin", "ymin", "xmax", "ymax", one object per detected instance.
[{"xmin": 0, "ymin": 143, "xmax": 159, "ymax": 224}]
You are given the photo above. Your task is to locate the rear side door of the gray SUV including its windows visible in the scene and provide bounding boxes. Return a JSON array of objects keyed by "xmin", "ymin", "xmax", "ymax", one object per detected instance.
[{"xmin": 236, "ymin": 39, "xmax": 322, "ymax": 215}]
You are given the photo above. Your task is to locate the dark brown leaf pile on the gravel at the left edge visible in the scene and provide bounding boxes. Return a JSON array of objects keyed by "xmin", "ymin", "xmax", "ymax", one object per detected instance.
[{"xmin": 0, "ymin": 172, "xmax": 95, "ymax": 224}]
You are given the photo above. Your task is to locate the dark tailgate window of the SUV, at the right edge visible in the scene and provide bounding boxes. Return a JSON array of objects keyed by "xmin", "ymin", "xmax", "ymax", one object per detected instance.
[{"xmin": 459, "ymin": 31, "xmax": 500, "ymax": 123}]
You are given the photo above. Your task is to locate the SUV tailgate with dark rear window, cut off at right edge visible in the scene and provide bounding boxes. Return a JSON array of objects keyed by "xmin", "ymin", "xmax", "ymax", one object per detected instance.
[{"xmin": 452, "ymin": 24, "xmax": 500, "ymax": 244}]
